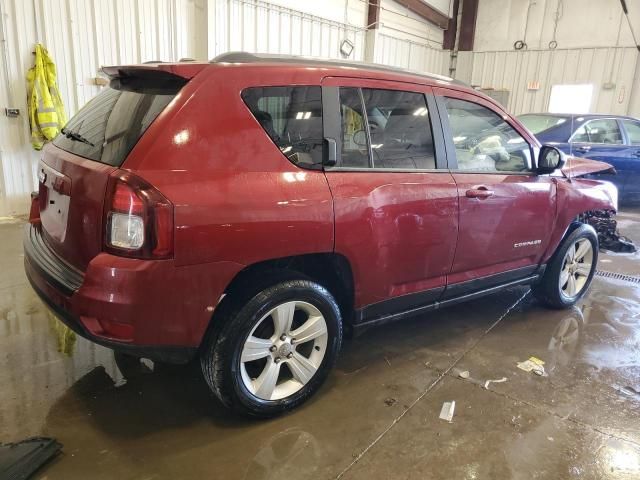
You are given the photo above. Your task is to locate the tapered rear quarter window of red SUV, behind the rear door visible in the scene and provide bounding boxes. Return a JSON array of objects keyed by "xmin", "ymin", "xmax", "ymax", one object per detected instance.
[{"xmin": 242, "ymin": 87, "xmax": 323, "ymax": 168}]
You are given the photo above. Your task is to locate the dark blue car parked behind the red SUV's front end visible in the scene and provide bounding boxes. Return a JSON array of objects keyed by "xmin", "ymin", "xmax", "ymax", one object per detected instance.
[{"xmin": 518, "ymin": 113, "xmax": 640, "ymax": 204}]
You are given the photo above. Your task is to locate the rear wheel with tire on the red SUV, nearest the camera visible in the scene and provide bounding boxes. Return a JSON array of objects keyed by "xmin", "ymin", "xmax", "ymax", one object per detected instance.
[{"xmin": 201, "ymin": 280, "xmax": 342, "ymax": 417}]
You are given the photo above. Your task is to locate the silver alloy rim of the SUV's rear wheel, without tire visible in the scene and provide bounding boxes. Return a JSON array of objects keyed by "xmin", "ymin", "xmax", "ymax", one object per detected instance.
[{"xmin": 240, "ymin": 301, "xmax": 328, "ymax": 400}]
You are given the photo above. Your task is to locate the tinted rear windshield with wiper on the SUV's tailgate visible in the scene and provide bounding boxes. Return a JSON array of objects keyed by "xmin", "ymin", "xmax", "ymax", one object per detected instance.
[{"xmin": 53, "ymin": 73, "xmax": 186, "ymax": 167}]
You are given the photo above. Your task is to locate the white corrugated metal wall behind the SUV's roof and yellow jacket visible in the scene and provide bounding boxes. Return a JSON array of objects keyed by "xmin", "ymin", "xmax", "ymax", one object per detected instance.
[{"xmin": 0, "ymin": 0, "xmax": 449, "ymax": 216}]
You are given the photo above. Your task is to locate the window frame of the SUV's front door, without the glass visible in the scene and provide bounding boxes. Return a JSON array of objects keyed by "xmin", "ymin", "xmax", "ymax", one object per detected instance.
[{"xmin": 435, "ymin": 88, "xmax": 539, "ymax": 177}]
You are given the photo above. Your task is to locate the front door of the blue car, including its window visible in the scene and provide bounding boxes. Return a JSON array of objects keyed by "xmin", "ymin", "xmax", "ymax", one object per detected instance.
[{"xmin": 569, "ymin": 118, "xmax": 630, "ymax": 196}]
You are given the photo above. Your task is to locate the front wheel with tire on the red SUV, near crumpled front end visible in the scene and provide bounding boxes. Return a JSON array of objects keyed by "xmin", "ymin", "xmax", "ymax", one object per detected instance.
[{"xmin": 533, "ymin": 224, "xmax": 598, "ymax": 309}]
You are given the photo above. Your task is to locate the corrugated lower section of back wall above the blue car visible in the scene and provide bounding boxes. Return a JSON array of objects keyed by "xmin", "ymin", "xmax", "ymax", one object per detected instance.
[{"xmin": 457, "ymin": 47, "xmax": 637, "ymax": 115}]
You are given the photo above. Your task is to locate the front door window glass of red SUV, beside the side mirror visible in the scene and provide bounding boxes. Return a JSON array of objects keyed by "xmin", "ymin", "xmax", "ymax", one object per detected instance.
[{"xmin": 444, "ymin": 98, "xmax": 533, "ymax": 172}]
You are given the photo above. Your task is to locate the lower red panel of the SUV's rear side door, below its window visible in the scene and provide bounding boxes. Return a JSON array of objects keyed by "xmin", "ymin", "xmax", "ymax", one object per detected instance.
[{"xmin": 327, "ymin": 172, "xmax": 458, "ymax": 307}]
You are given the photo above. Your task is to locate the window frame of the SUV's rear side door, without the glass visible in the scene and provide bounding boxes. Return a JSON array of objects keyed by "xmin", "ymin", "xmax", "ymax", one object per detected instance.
[{"xmin": 322, "ymin": 77, "xmax": 449, "ymax": 173}]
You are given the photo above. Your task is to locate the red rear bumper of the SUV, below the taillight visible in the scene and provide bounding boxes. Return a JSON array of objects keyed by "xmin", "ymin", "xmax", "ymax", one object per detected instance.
[{"xmin": 23, "ymin": 223, "xmax": 241, "ymax": 363}]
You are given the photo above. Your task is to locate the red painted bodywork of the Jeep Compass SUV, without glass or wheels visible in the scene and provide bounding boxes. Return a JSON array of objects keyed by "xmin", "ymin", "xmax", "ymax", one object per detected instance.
[{"xmin": 27, "ymin": 63, "xmax": 612, "ymax": 347}]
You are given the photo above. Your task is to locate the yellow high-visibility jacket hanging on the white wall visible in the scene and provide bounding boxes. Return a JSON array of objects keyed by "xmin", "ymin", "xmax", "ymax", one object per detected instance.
[{"xmin": 27, "ymin": 43, "xmax": 67, "ymax": 150}]
